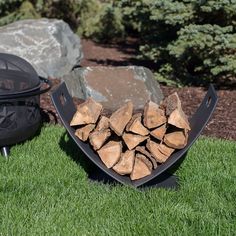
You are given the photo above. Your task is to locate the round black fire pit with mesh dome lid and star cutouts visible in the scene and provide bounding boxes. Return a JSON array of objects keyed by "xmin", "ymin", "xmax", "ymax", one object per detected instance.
[{"xmin": 0, "ymin": 53, "xmax": 51, "ymax": 156}]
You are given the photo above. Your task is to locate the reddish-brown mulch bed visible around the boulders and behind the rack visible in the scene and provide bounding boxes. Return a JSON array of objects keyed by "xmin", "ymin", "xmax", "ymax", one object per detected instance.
[{"xmin": 41, "ymin": 39, "xmax": 236, "ymax": 140}]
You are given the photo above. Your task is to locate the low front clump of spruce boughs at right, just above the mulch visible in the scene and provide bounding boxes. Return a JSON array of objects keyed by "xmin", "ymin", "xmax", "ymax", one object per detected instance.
[{"xmin": 167, "ymin": 24, "xmax": 236, "ymax": 84}]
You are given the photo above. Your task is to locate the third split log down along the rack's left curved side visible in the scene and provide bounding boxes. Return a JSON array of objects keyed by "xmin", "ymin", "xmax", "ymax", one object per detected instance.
[{"xmin": 89, "ymin": 129, "xmax": 111, "ymax": 150}]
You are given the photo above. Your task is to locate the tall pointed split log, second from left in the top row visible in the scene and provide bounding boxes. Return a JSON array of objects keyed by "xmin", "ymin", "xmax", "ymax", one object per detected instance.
[{"xmin": 110, "ymin": 101, "xmax": 133, "ymax": 136}]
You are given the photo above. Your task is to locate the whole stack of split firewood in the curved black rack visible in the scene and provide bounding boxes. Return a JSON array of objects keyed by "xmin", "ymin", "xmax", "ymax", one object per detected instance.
[{"xmin": 70, "ymin": 93, "xmax": 190, "ymax": 180}]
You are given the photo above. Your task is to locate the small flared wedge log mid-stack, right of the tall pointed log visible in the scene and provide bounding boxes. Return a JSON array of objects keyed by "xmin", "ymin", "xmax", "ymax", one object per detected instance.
[{"xmin": 126, "ymin": 113, "xmax": 149, "ymax": 136}]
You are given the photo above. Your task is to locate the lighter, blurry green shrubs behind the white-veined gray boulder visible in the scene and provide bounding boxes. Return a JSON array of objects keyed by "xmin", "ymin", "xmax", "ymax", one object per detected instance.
[{"xmin": 0, "ymin": 0, "xmax": 124, "ymax": 41}]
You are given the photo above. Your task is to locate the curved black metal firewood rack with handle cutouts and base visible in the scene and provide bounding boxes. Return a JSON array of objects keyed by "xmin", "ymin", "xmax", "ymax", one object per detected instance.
[{"xmin": 51, "ymin": 83, "xmax": 218, "ymax": 187}]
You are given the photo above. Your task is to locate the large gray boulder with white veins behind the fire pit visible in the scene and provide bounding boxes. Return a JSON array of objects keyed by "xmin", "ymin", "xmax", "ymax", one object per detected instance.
[{"xmin": 0, "ymin": 19, "xmax": 82, "ymax": 78}]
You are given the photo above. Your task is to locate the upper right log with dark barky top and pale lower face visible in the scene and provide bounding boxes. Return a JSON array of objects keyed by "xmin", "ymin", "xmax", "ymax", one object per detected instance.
[{"xmin": 161, "ymin": 92, "xmax": 191, "ymax": 130}]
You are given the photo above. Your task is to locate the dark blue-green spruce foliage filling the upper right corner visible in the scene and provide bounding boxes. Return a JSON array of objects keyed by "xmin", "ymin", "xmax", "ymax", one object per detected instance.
[{"xmin": 116, "ymin": 0, "xmax": 236, "ymax": 84}]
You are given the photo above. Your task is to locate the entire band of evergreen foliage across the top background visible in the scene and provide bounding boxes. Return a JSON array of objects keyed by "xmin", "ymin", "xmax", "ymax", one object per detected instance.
[{"xmin": 0, "ymin": 0, "xmax": 236, "ymax": 84}]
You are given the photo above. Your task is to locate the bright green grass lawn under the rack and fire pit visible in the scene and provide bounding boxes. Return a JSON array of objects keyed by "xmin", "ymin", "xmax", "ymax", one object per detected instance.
[{"xmin": 0, "ymin": 126, "xmax": 236, "ymax": 236}]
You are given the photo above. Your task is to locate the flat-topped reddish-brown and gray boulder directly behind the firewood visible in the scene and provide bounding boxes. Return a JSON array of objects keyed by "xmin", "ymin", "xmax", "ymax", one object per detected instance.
[{"xmin": 62, "ymin": 66, "xmax": 163, "ymax": 111}]
